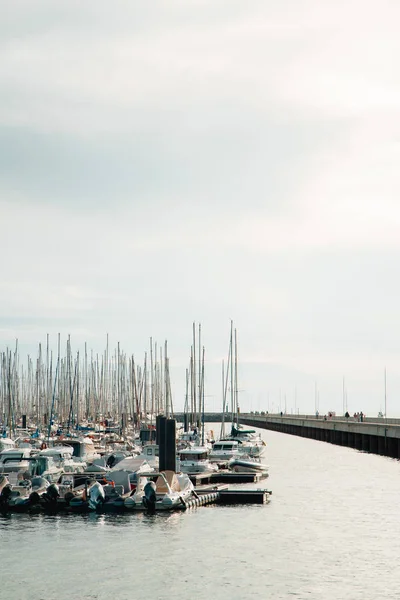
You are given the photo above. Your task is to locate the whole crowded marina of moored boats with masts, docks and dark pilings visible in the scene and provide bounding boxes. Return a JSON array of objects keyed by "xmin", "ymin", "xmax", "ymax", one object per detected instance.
[{"xmin": 0, "ymin": 322, "xmax": 271, "ymax": 514}]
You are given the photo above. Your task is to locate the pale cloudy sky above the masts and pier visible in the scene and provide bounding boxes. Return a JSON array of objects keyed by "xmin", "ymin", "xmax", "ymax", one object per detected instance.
[{"xmin": 0, "ymin": 0, "xmax": 400, "ymax": 416}]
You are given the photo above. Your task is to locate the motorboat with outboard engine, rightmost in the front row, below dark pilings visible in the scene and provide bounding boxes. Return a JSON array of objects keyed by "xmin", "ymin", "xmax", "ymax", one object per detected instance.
[{"xmin": 124, "ymin": 471, "xmax": 195, "ymax": 512}]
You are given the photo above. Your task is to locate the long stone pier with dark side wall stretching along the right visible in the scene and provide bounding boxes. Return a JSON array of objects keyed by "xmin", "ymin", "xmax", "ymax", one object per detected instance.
[{"xmin": 240, "ymin": 414, "xmax": 400, "ymax": 458}]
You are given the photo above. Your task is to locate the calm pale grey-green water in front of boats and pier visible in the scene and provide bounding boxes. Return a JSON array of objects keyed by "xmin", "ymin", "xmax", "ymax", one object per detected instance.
[{"xmin": 0, "ymin": 427, "xmax": 400, "ymax": 600}]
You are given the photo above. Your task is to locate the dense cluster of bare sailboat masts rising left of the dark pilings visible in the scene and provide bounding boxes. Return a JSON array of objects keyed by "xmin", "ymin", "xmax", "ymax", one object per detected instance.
[{"xmin": 0, "ymin": 335, "xmax": 173, "ymax": 431}]
